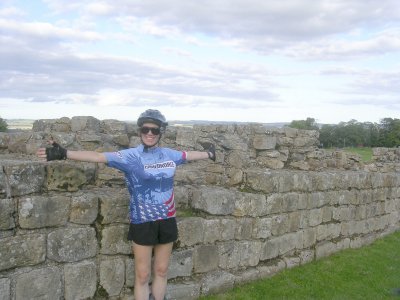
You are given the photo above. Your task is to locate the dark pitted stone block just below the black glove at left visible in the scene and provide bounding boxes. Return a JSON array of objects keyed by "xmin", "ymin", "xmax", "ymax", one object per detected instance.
[{"xmin": 47, "ymin": 162, "xmax": 96, "ymax": 192}]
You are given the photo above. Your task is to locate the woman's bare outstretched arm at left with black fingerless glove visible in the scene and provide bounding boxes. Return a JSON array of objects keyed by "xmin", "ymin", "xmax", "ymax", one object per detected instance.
[{"xmin": 36, "ymin": 141, "xmax": 107, "ymax": 163}]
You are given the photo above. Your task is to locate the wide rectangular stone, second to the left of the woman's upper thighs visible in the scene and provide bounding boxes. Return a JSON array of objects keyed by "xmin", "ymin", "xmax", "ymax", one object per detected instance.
[{"xmin": 47, "ymin": 227, "xmax": 97, "ymax": 262}]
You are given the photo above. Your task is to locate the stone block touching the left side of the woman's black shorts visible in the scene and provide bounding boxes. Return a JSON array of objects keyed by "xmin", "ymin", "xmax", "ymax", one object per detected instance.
[{"xmin": 100, "ymin": 224, "xmax": 132, "ymax": 255}]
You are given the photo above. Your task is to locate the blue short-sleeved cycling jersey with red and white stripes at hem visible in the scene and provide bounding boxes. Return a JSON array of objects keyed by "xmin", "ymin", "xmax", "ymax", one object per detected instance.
[{"xmin": 105, "ymin": 145, "xmax": 186, "ymax": 224}]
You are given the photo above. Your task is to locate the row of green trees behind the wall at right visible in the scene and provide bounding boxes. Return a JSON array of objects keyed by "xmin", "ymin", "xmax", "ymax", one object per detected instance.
[{"xmin": 288, "ymin": 118, "xmax": 400, "ymax": 148}]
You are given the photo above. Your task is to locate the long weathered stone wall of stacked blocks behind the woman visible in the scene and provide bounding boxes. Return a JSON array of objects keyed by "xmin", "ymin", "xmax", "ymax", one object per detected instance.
[{"xmin": 0, "ymin": 117, "xmax": 400, "ymax": 300}]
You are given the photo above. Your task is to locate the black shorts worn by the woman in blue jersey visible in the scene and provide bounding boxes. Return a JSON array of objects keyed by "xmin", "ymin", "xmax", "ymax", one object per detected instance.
[{"xmin": 128, "ymin": 218, "xmax": 178, "ymax": 246}]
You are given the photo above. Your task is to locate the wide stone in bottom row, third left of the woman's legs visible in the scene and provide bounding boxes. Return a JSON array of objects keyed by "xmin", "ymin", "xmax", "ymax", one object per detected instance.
[{"xmin": 15, "ymin": 267, "xmax": 63, "ymax": 300}]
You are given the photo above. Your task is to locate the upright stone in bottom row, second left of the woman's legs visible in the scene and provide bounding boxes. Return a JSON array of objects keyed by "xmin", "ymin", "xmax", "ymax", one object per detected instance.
[{"xmin": 64, "ymin": 261, "xmax": 97, "ymax": 300}]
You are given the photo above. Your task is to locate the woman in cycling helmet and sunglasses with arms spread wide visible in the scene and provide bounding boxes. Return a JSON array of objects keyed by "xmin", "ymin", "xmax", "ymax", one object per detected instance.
[{"xmin": 37, "ymin": 109, "xmax": 215, "ymax": 300}]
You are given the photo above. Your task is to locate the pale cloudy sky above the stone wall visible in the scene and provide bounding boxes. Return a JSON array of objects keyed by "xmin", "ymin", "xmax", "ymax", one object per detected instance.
[{"xmin": 0, "ymin": 0, "xmax": 400, "ymax": 124}]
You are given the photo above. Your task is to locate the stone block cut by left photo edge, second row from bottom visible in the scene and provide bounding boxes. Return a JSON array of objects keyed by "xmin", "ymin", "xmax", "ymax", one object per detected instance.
[{"xmin": 0, "ymin": 234, "xmax": 46, "ymax": 271}]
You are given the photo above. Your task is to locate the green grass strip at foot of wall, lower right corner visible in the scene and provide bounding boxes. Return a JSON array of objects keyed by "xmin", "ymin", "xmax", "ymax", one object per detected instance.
[{"xmin": 200, "ymin": 231, "xmax": 400, "ymax": 300}]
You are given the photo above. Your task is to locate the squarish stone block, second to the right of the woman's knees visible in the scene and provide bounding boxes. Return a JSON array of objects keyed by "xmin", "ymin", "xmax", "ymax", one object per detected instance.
[{"xmin": 193, "ymin": 245, "xmax": 219, "ymax": 273}]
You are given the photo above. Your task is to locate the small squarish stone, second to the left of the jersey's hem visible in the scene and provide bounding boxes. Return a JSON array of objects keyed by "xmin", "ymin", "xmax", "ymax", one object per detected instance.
[{"xmin": 70, "ymin": 191, "xmax": 99, "ymax": 225}]
